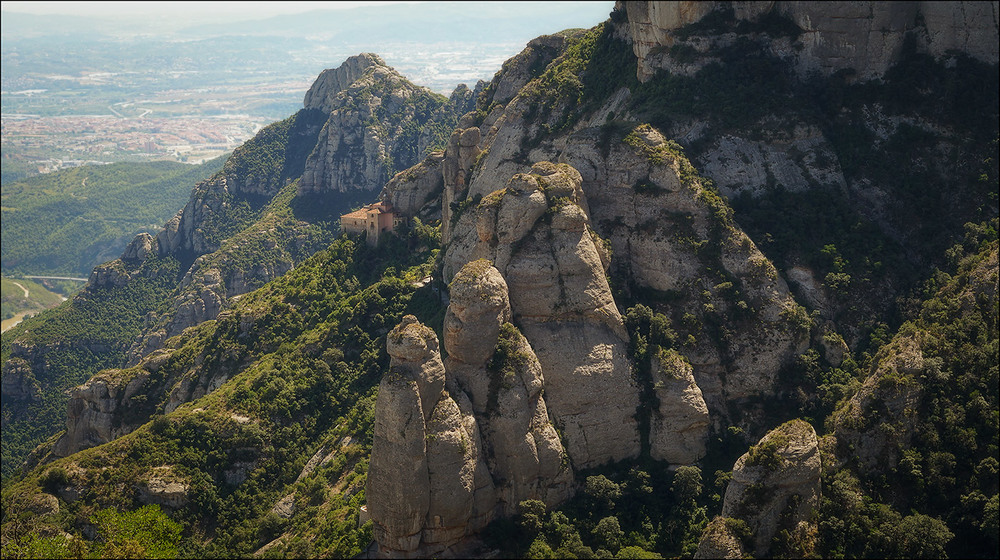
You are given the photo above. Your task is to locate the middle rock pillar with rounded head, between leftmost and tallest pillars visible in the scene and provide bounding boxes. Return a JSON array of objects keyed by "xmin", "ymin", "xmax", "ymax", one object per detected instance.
[{"xmin": 444, "ymin": 260, "xmax": 573, "ymax": 516}]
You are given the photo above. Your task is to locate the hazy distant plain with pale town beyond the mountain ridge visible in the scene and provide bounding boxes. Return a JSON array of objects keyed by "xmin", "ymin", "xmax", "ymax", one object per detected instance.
[{"xmin": 0, "ymin": 40, "xmax": 520, "ymax": 177}]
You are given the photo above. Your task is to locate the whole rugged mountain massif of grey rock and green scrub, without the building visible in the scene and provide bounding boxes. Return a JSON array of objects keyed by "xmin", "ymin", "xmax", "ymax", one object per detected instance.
[{"xmin": 2, "ymin": 2, "xmax": 1000, "ymax": 558}]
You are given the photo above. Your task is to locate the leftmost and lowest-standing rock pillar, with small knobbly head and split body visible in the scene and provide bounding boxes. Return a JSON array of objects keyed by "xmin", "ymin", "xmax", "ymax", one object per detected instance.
[{"xmin": 366, "ymin": 315, "xmax": 496, "ymax": 557}]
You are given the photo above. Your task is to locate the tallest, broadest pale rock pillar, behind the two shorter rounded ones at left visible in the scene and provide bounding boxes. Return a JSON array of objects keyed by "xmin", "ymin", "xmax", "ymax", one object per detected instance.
[{"xmin": 444, "ymin": 162, "xmax": 639, "ymax": 468}]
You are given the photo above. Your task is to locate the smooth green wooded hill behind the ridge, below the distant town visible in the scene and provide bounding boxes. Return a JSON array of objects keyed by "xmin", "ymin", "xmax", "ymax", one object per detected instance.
[{"xmin": 2, "ymin": 158, "xmax": 223, "ymax": 277}]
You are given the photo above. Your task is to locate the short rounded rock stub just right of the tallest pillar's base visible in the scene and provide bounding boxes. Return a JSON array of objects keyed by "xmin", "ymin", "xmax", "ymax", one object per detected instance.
[{"xmin": 649, "ymin": 351, "xmax": 709, "ymax": 465}]
